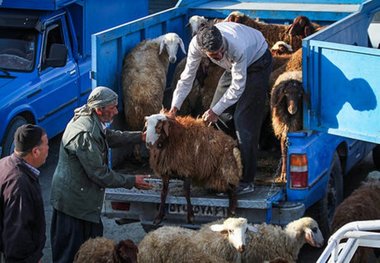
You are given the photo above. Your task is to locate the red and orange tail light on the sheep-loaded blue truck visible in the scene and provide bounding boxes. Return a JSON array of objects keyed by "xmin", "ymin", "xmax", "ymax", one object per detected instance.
[{"xmin": 290, "ymin": 154, "xmax": 308, "ymax": 188}]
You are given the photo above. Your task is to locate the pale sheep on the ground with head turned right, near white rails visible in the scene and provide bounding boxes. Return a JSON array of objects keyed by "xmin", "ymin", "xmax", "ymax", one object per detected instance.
[{"xmin": 242, "ymin": 217, "xmax": 324, "ymax": 263}]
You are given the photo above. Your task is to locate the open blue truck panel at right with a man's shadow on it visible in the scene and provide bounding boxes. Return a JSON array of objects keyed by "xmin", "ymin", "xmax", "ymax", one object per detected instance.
[{"xmin": 303, "ymin": 1, "xmax": 380, "ymax": 143}]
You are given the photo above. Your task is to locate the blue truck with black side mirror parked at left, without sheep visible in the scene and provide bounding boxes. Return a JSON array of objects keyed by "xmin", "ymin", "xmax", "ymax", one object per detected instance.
[{"xmin": 0, "ymin": 0, "xmax": 148, "ymax": 156}]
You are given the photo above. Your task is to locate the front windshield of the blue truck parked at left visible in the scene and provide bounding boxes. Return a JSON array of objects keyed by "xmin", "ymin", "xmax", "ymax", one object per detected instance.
[{"xmin": 0, "ymin": 28, "xmax": 38, "ymax": 71}]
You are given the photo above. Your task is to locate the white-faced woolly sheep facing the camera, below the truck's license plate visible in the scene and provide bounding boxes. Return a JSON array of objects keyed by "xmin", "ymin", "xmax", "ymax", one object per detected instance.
[{"xmin": 138, "ymin": 218, "xmax": 254, "ymax": 263}]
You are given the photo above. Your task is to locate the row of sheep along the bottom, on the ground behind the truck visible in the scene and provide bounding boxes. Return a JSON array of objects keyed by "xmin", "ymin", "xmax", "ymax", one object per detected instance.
[{"xmin": 74, "ymin": 217, "xmax": 324, "ymax": 263}]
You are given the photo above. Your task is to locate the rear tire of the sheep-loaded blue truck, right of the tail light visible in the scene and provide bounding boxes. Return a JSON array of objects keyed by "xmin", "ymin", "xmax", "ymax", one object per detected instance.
[{"xmin": 306, "ymin": 153, "xmax": 343, "ymax": 238}]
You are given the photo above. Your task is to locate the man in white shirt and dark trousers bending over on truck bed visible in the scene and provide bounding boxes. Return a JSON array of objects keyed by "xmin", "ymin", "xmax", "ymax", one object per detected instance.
[{"xmin": 169, "ymin": 22, "xmax": 272, "ymax": 193}]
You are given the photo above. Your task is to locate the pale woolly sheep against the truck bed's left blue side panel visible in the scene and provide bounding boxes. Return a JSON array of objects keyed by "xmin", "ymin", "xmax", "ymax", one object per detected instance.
[{"xmin": 122, "ymin": 33, "xmax": 186, "ymax": 130}]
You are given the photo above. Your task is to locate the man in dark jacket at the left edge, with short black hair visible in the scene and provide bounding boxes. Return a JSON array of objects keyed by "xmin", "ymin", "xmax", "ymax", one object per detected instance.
[{"xmin": 0, "ymin": 124, "xmax": 49, "ymax": 263}]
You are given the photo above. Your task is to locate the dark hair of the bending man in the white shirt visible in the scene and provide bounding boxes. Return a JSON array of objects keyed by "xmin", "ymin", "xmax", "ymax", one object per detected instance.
[{"xmin": 197, "ymin": 25, "xmax": 223, "ymax": 52}]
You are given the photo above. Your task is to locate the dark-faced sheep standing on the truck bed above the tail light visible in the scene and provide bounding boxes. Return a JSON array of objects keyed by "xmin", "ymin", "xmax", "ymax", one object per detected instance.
[{"xmin": 270, "ymin": 71, "xmax": 304, "ymax": 183}]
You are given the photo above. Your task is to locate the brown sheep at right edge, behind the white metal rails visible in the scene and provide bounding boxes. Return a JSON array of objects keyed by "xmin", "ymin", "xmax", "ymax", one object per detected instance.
[{"xmin": 331, "ymin": 180, "xmax": 380, "ymax": 263}]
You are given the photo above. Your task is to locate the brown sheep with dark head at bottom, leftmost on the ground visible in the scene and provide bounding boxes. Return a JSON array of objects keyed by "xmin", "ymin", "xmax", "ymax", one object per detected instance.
[{"xmin": 74, "ymin": 237, "xmax": 138, "ymax": 263}]
